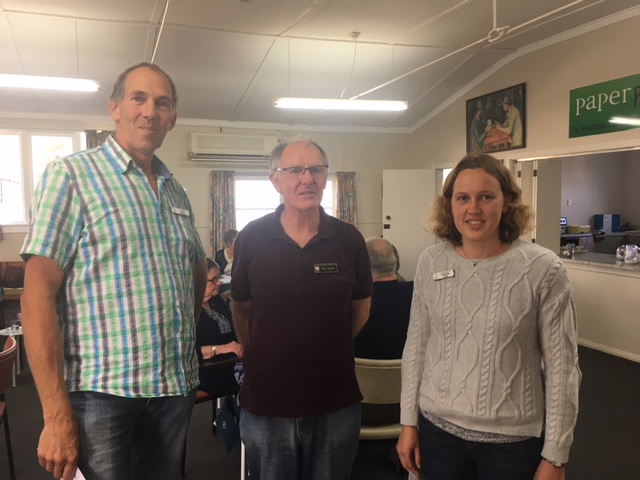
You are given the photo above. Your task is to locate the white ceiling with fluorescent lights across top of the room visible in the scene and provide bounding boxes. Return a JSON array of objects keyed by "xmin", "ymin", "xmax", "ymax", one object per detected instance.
[{"xmin": 0, "ymin": 0, "xmax": 640, "ymax": 131}]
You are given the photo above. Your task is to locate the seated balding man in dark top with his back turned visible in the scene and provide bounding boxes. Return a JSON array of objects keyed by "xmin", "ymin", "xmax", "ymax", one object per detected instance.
[{"xmin": 354, "ymin": 237, "xmax": 413, "ymax": 359}]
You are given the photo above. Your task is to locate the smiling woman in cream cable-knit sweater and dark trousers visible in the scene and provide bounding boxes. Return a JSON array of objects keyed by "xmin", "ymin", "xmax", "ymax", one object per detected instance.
[{"xmin": 397, "ymin": 154, "xmax": 581, "ymax": 480}]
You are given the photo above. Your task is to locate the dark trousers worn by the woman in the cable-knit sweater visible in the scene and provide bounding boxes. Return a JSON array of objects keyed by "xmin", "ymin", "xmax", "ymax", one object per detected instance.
[{"xmin": 418, "ymin": 415, "xmax": 543, "ymax": 480}]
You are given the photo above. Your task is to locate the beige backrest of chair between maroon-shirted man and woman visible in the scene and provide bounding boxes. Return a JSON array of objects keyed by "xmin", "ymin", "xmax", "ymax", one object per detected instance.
[{"xmin": 355, "ymin": 358, "xmax": 402, "ymax": 405}]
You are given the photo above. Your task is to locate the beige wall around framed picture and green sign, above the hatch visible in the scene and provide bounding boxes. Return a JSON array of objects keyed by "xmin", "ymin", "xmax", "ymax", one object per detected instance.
[{"xmin": 410, "ymin": 16, "xmax": 640, "ymax": 166}]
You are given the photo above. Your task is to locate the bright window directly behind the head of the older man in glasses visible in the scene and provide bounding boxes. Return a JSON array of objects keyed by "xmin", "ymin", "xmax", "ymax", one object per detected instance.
[{"xmin": 235, "ymin": 174, "xmax": 335, "ymax": 230}]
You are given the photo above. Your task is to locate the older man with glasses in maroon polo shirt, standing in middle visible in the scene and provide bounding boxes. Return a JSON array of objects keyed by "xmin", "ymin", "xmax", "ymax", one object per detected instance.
[{"xmin": 231, "ymin": 141, "xmax": 372, "ymax": 480}]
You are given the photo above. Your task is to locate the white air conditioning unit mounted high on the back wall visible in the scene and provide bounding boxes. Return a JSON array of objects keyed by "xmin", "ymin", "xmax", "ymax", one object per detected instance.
[{"xmin": 189, "ymin": 132, "xmax": 278, "ymax": 164}]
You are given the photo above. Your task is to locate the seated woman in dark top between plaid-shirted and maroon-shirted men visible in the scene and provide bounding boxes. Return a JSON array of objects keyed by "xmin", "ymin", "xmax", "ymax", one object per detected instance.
[{"xmin": 196, "ymin": 258, "xmax": 243, "ymax": 397}]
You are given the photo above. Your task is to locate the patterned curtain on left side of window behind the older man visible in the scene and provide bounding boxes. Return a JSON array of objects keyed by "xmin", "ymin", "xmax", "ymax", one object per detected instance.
[{"xmin": 209, "ymin": 170, "xmax": 236, "ymax": 257}]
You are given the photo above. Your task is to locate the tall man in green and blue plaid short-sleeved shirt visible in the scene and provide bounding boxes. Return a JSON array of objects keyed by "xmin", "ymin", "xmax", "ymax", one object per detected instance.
[{"xmin": 21, "ymin": 63, "xmax": 206, "ymax": 480}]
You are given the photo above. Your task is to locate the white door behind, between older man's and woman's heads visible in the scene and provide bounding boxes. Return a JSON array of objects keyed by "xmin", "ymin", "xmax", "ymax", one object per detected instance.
[{"xmin": 382, "ymin": 170, "xmax": 436, "ymax": 280}]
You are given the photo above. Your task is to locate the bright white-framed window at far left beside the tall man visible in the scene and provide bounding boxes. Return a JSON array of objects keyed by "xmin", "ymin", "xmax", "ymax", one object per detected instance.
[{"xmin": 0, "ymin": 130, "xmax": 84, "ymax": 232}]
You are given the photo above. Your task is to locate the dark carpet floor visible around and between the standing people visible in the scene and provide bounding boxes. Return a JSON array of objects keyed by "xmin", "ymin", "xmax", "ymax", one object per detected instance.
[{"xmin": 0, "ymin": 347, "xmax": 640, "ymax": 480}]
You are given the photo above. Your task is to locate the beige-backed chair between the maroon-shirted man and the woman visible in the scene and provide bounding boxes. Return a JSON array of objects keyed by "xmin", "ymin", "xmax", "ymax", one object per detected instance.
[{"xmin": 355, "ymin": 358, "xmax": 404, "ymax": 476}]
